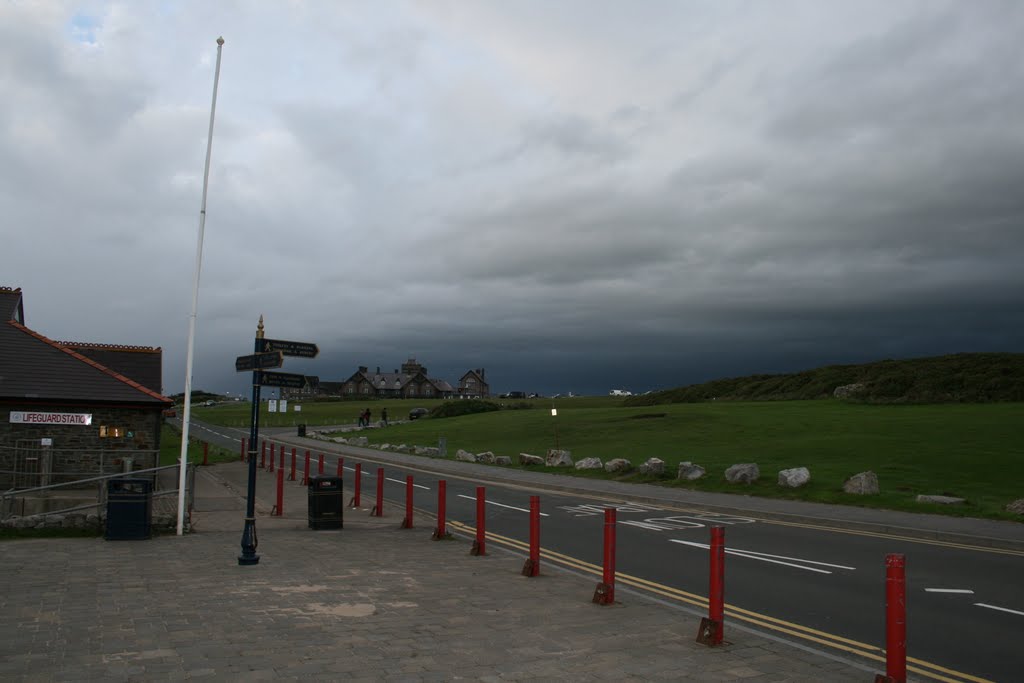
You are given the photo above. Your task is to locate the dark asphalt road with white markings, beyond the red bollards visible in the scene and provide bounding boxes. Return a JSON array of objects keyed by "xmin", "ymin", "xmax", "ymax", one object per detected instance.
[{"xmin": 180, "ymin": 423, "xmax": 1024, "ymax": 681}]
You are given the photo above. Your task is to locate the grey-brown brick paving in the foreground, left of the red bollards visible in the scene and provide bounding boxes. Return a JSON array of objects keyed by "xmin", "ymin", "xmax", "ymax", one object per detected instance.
[{"xmin": 0, "ymin": 464, "xmax": 872, "ymax": 682}]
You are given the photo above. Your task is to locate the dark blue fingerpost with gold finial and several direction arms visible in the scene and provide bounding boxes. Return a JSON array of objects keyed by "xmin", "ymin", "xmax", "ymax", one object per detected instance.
[{"xmin": 234, "ymin": 315, "xmax": 319, "ymax": 564}]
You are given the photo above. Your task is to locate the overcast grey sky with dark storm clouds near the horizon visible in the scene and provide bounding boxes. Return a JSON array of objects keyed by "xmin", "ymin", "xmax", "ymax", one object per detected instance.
[{"xmin": 0, "ymin": 0, "xmax": 1024, "ymax": 394}]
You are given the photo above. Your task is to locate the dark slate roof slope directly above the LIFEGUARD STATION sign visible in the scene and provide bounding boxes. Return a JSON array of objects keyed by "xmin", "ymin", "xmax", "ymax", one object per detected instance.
[{"xmin": 0, "ymin": 319, "xmax": 173, "ymax": 407}]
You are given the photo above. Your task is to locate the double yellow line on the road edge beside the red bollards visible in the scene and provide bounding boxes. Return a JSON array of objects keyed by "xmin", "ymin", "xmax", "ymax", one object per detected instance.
[{"xmin": 449, "ymin": 521, "xmax": 992, "ymax": 683}]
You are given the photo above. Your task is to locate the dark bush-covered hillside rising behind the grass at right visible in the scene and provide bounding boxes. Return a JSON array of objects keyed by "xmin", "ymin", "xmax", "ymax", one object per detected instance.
[{"xmin": 625, "ymin": 353, "xmax": 1024, "ymax": 405}]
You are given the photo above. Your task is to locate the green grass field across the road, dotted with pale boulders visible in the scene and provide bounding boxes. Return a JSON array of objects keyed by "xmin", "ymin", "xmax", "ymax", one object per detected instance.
[{"xmin": 196, "ymin": 396, "xmax": 1024, "ymax": 520}]
